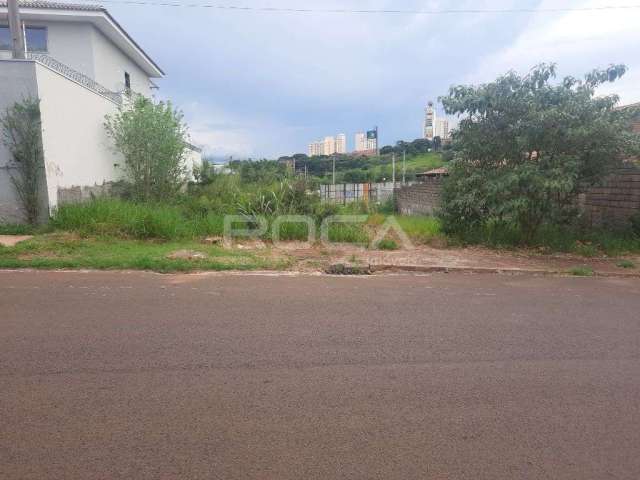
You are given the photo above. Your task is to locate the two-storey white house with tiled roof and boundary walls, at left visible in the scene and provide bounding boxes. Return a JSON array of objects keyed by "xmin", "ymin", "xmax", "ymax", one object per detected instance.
[{"xmin": 0, "ymin": 0, "xmax": 202, "ymax": 222}]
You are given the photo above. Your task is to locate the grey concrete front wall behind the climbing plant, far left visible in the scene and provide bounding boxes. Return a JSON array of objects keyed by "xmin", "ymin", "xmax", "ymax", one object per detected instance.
[{"xmin": 0, "ymin": 60, "xmax": 47, "ymax": 223}]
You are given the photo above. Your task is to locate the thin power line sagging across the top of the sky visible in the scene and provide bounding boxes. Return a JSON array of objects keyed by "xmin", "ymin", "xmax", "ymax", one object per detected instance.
[{"xmin": 61, "ymin": 0, "xmax": 640, "ymax": 15}]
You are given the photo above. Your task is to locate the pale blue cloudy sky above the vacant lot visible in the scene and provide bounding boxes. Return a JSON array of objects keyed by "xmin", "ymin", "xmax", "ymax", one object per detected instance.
[{"xmin": 105, "ymin": 0, "xmax": 640, "ymax": 158}]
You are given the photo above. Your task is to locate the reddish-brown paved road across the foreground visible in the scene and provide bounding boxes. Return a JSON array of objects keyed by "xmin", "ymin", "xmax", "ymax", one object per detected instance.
[{"xmin": 0, "ymin": 272, "xmax": 640, "ymax": 480}]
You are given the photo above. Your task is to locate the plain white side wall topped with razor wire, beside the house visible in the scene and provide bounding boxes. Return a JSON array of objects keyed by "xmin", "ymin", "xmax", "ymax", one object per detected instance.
[{"xmin": 36, "ymin": 60, "xmax": 122, "ymax": 208}]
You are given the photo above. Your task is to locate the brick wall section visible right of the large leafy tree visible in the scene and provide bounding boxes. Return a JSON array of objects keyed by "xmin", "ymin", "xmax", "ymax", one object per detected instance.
[{"xmin": 578, "ymin": 166, "xmax": 640, "ymax": 227}]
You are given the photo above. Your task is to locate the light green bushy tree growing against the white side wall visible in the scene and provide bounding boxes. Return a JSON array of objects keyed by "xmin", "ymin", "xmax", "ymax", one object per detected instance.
[{"xmin": 104, "ymin": 96, "xmax": 188, "ymax": 200}]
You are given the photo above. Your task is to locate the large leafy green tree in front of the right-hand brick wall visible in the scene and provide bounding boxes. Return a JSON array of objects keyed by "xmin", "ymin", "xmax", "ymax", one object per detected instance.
[{"xmin": 440, "ymin": 64, "xmax": 638, "ymax": 243}]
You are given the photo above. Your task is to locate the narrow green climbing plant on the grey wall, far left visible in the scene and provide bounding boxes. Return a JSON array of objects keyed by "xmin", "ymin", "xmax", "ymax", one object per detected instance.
[{"xmin": 0, "ymin": 98, "xmax": 44, "ymax": 224}]
